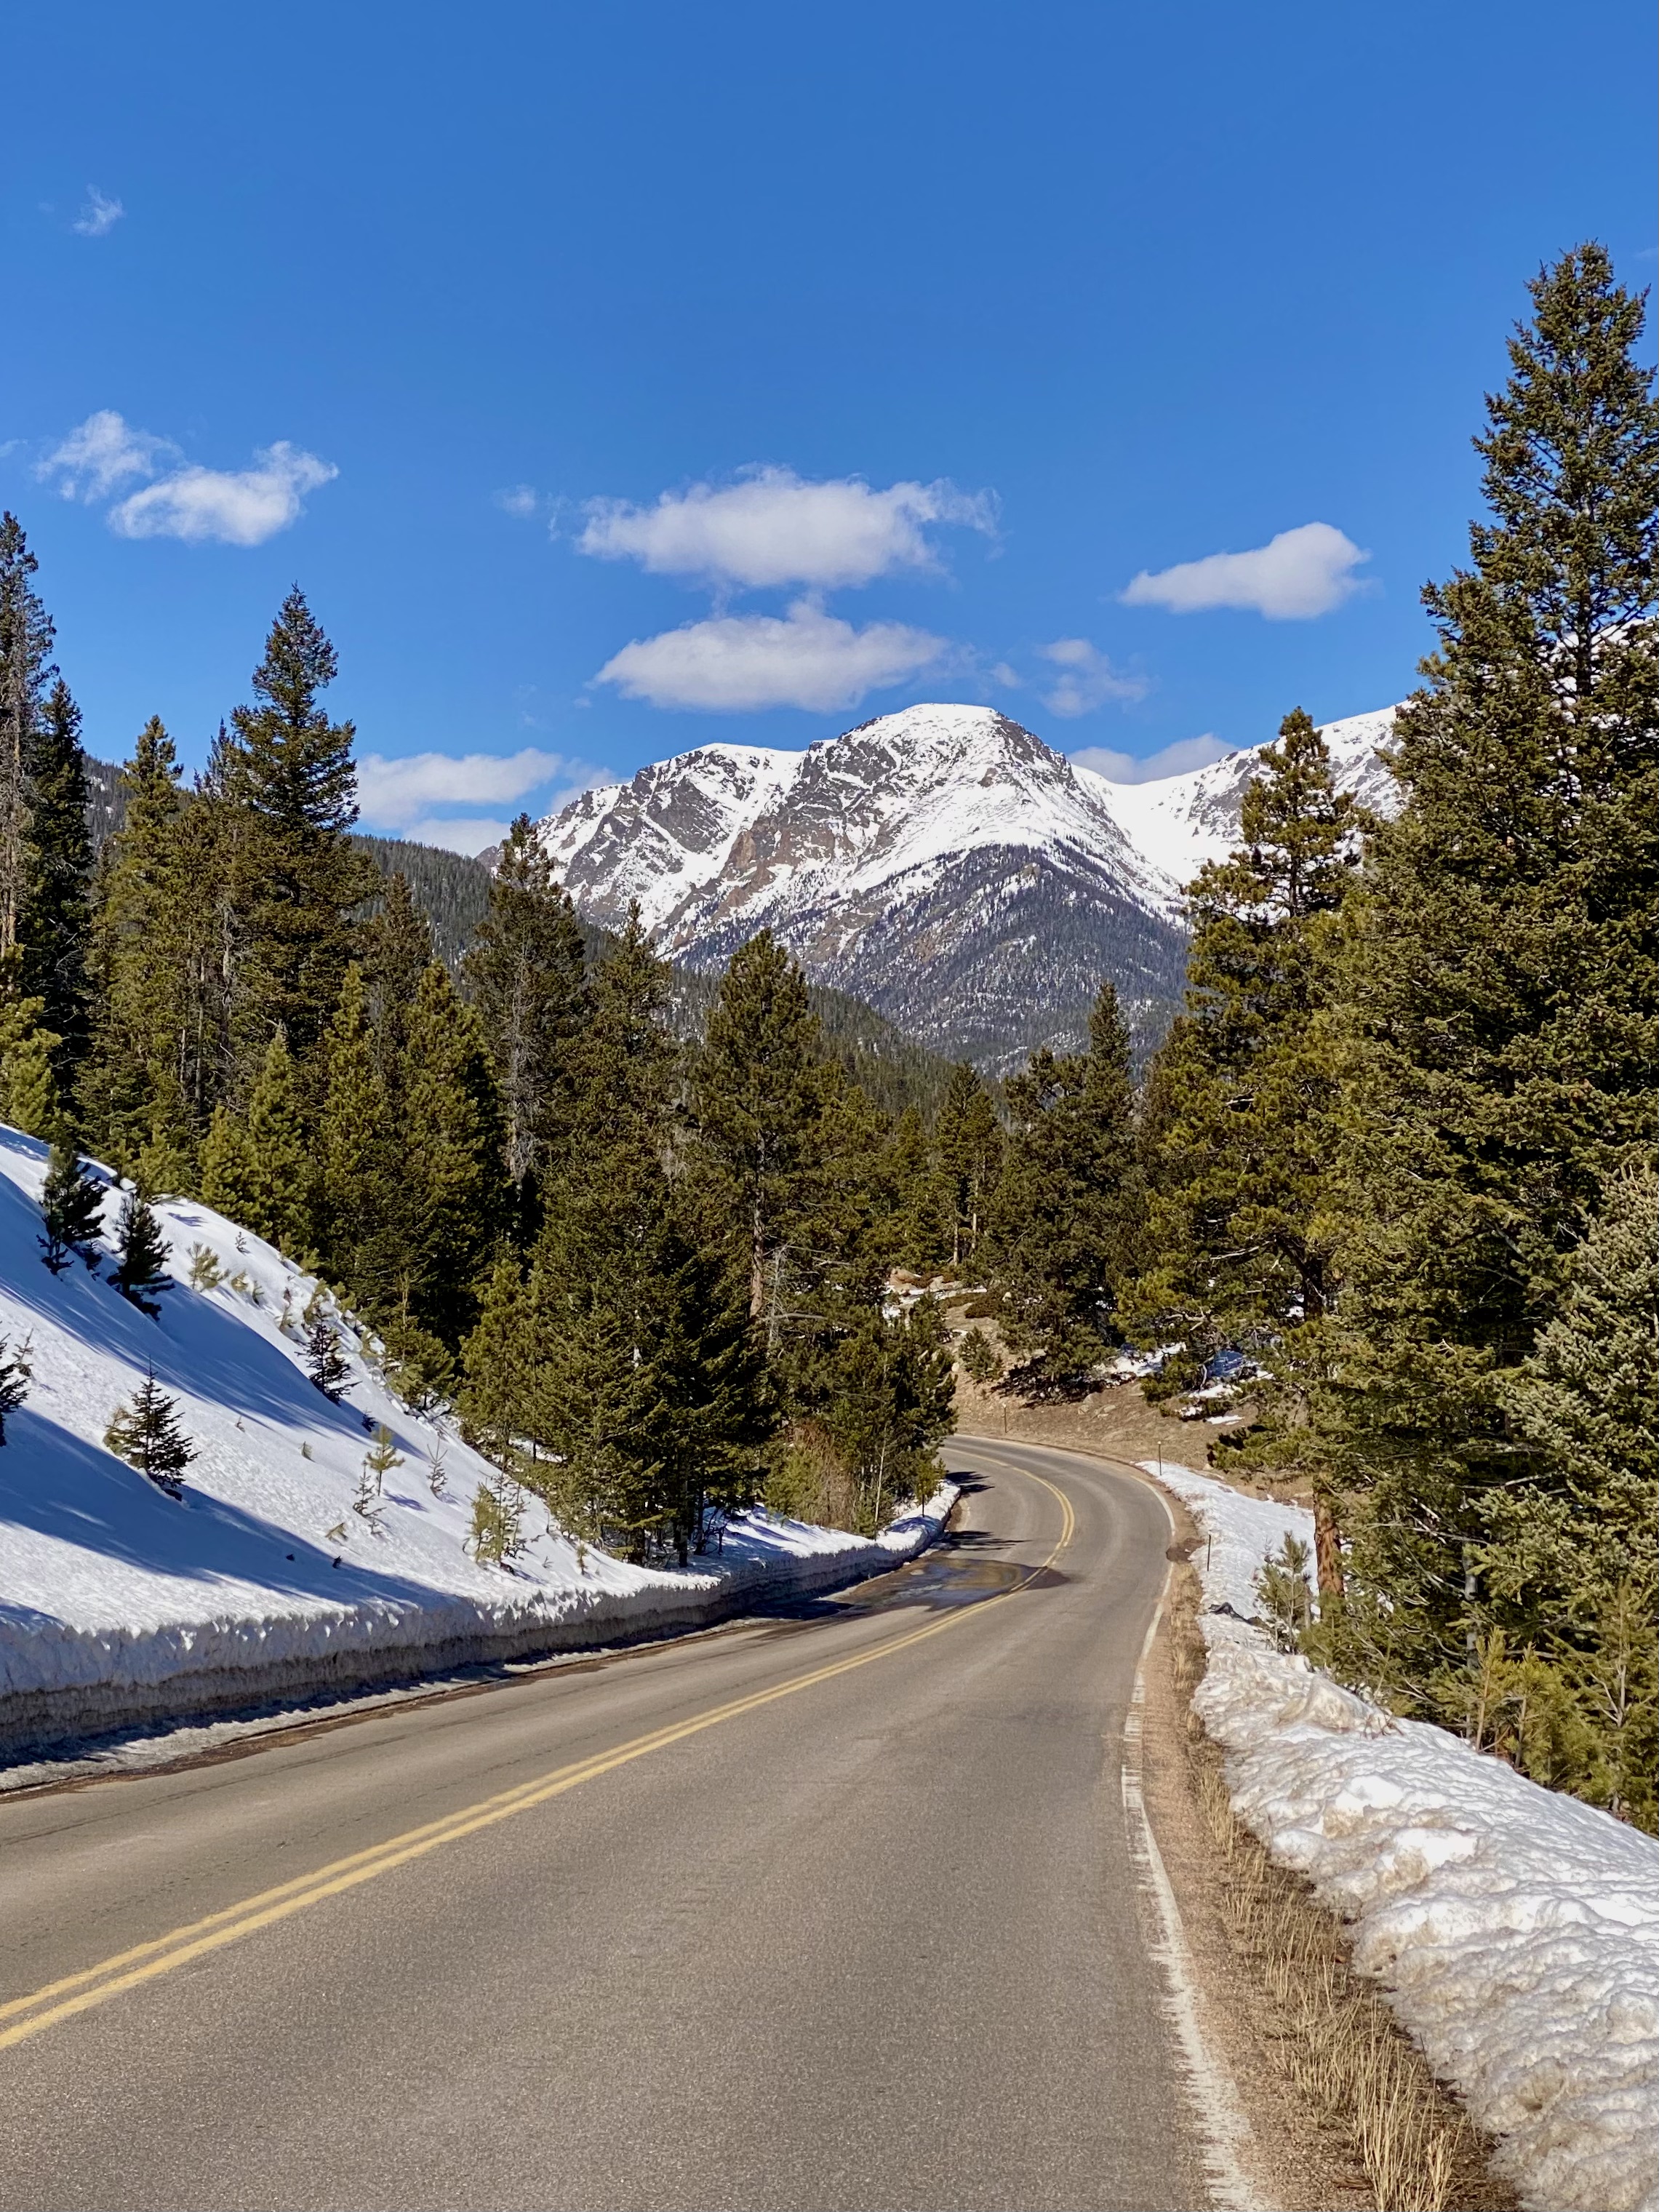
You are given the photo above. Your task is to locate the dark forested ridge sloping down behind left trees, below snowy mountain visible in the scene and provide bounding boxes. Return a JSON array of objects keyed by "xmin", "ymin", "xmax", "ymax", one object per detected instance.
[{"xmin": 87, "ymin": 754, "xmax": 951, "ymax": 1117}]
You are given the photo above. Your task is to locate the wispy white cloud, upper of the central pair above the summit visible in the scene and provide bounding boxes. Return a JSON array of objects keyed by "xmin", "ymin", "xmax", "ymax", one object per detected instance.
[{"xmin": 577, "ymin": 467, "xmax": 996, "ymax": 591}]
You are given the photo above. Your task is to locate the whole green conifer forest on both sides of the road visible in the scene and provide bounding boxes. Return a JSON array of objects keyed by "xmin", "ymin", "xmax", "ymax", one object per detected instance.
[{"xmin": 0, "ymin": 246, "xmax": 1659, "ymax": 1829}]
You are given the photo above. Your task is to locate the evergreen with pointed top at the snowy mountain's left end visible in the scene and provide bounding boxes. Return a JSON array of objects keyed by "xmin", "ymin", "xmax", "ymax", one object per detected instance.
[{"xmin": 465, "ymin": 814, "xmax": 588, "ymax": 1212}]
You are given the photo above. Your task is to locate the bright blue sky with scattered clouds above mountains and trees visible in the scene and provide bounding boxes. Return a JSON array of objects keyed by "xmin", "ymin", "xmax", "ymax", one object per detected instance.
[{"xmin": 0, "ymin": 0, "xmax": 1655, "ymax": 847}]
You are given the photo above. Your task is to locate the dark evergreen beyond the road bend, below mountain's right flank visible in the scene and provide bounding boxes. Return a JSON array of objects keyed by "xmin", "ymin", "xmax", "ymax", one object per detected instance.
[{"xmin": 988, "ymin": 984, "xmax": 1143, "ymax": 1392}]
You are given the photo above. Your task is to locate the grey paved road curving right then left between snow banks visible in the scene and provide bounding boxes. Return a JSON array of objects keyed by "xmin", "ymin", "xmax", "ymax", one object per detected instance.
[{"xmin": 0, "ymin": 1442, "xmax": 1208, "ymax": 2208}]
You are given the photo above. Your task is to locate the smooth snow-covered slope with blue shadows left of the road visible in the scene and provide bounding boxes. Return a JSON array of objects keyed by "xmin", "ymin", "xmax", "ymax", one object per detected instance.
[{"xmin": 0, "ymin": 1128, "xmax": 956, "ymax": 1759}]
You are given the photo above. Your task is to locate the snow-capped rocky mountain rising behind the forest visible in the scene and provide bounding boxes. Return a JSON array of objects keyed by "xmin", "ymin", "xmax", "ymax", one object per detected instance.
[{"xmin": 542, "ymin": 706, "xmax": 1391, "ymax": 1066}]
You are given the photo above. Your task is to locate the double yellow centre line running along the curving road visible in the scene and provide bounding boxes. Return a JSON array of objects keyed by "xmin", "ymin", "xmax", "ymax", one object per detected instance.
[{"xmin": 0, "ymin": 1466, "xmax": 1077, "ymax": 2051}]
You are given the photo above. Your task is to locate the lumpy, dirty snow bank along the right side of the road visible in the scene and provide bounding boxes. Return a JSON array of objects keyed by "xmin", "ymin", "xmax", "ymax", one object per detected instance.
[{"xmin": 1141, "ymin": 1462, "xmax": 1659, "ymax": 2212}]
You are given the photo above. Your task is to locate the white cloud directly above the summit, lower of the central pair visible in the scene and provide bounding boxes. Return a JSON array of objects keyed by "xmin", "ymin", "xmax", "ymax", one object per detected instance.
[{"xmin": 593, "ymin": 599, "xmax": 947, "ymax": 712}]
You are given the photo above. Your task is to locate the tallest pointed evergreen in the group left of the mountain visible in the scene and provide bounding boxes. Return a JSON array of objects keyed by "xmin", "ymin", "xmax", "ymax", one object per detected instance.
[{"xmin": 232, "ymin": 588, "xmax": 376, "ymax": 1069}]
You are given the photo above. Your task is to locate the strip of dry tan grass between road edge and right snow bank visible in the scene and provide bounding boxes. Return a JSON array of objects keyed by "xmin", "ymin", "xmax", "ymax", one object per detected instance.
[{"xmin": 1175, "ymin": 1613, "xmax": 1513, "ymax": 2212}]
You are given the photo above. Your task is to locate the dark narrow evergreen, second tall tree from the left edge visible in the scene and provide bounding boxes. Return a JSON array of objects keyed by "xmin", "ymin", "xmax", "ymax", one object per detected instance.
[{"xmin": 20, "ymin": 677, "xmax": 93, "ymax": 1079}]
